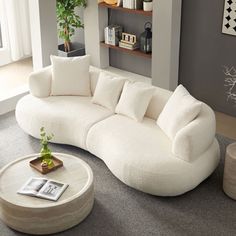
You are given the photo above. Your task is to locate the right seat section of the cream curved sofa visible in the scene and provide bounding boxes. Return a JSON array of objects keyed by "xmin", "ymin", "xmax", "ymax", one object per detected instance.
[{"xmin": 87, "ymin": 115, "xmax": 219, "ymax": 196}]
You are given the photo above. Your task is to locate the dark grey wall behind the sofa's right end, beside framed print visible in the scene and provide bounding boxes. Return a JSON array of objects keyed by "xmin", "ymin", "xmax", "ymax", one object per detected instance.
[{"xmin": 179, "ymin": 0, "xmax": 236, "ymax": 116}]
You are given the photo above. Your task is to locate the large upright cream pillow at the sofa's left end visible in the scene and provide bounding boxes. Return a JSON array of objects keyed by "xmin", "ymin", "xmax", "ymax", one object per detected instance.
[{"xmin": 51, "ymin": 55, "xmax": 91, "ymax": 96}]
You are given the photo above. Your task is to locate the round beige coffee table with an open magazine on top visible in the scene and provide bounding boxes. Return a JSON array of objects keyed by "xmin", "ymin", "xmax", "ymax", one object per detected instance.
[{"xmin": 0, "ymin": 153, "xmax": 94, "ymax": 234}]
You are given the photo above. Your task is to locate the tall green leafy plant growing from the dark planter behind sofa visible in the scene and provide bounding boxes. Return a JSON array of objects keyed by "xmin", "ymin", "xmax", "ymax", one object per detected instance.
[{"xmin": 57, "ymin": 0, "xmax": 87, "ymax": 52}]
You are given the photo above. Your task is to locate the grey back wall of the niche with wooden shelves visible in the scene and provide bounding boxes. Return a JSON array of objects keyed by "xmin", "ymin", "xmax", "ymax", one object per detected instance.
[{"xmin": 109, "ymin": 10, "xmax": 152, "ymax": 77}]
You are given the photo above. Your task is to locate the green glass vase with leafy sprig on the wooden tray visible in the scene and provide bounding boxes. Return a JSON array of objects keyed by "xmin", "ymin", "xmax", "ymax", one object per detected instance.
[{"xmin": 40, "ymin": 127, "xmax": 54, "ymax": 169}]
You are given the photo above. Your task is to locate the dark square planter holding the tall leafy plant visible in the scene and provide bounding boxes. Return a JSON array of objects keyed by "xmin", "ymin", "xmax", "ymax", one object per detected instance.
[{"xmin": 58, "ymin": 42, "xmax": 85, "ymax": 57}]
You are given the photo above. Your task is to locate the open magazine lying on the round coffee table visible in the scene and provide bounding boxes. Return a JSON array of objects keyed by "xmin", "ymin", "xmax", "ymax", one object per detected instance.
[{"xmin": 17, "ymin": 177, "xmax": 69, "ymax": 201}]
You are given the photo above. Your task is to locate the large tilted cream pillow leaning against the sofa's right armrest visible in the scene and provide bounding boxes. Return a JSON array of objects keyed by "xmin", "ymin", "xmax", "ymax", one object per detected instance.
[{"xmin": 157, "ymin": 85, "xmax": 202, "ymax": 140}]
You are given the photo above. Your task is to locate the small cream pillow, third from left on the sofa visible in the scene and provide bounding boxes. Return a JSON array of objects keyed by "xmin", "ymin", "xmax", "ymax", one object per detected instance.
[{"xmin": 115, "ymin": 81, "xmax": 155, "ymax": 122}]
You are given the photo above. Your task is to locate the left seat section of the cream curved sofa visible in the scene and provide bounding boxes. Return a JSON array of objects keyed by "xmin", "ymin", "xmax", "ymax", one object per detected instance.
[{"xmin": 16, "ymin": 95, "xmax": 113, "ymax": 149}]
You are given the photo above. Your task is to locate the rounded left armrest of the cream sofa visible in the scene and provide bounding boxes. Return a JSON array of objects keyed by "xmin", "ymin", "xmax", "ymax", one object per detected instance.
[{"xmin": 29, "ymin": 66, "xmax": 52, "ymax": 98}]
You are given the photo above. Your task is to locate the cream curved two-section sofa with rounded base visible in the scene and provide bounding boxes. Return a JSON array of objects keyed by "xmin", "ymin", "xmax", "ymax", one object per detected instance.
[{"xmin": 16, "ymin": 67, "xmax": 219, "ymax": 196}]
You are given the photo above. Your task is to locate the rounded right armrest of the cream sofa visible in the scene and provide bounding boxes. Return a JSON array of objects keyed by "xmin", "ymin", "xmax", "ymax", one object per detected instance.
[{"xmin": 172, "ymin": 104, "xmax": 216, "ymax": 162}]
